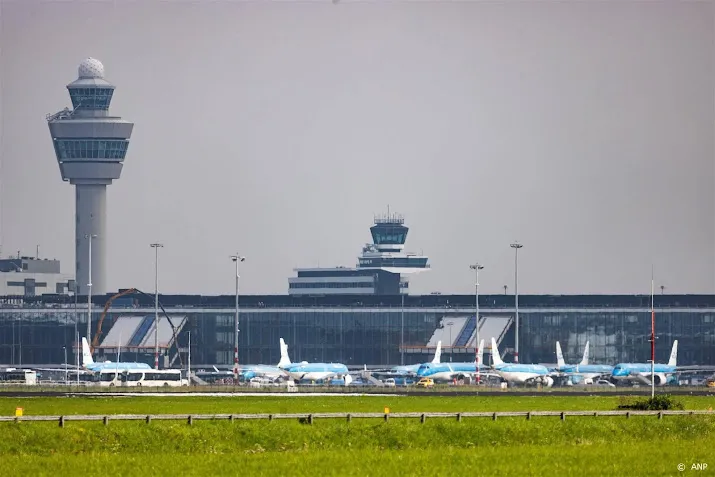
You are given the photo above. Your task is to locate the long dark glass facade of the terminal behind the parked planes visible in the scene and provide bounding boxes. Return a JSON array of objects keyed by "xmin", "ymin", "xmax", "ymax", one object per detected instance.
[{"xmin": 0, "ymin": 294, "xmax": 715, "ymax": 368}]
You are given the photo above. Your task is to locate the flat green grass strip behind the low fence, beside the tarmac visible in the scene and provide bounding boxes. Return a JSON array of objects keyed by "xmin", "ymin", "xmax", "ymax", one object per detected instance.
[{"xmin": 0, "ymin": 395, "xmax": 715, "ymax": 416}]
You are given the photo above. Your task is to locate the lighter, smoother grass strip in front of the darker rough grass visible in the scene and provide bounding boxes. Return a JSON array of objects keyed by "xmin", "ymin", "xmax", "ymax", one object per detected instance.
[{"xmin": 0, "ymin": 442, "xmax": 713, "ymax": 477}]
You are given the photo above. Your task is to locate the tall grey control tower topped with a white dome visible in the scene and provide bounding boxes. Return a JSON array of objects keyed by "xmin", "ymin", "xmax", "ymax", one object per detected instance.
[{"xmin": 47, "ymin": 58, "xmax": 134, "ymax": 295}]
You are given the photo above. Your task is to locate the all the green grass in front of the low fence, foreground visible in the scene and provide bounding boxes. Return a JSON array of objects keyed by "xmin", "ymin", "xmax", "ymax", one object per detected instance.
[{"xmin": 0, "ymin": 416, "xmax": 715, "ymax": 476}]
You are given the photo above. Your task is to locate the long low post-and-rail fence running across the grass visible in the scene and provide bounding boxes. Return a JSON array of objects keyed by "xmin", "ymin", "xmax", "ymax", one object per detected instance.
[{"xmin": 0, "ymin": 410, "xmax": 715, "ymax": 427}]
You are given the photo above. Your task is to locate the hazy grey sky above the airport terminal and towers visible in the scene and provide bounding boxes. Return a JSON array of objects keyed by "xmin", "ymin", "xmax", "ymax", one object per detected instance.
[{"xmin": 0, "ymin": 0, "xmax": 715, "ymax": 294}]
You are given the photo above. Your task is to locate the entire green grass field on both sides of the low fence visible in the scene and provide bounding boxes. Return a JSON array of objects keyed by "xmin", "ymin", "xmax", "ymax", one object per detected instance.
[{"xmin": 0, "ymin": 396, "xmax": 715, "ymax": 476}]
